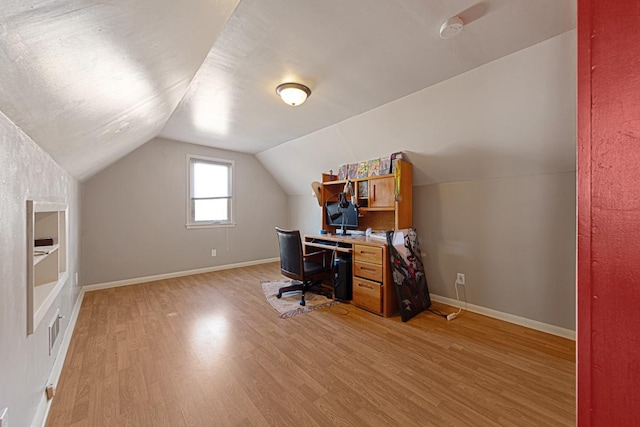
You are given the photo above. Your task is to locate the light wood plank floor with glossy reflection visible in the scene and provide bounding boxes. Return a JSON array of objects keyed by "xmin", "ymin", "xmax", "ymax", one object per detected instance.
[{"xmin": 47, "ymin": 263, "xmax": 575, "ymax": 427}]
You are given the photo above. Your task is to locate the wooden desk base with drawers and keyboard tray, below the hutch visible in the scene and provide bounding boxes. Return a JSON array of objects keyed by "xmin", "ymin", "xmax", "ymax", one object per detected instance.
[{"xmin": 304, "ymin": 234, "xmax": 398, "ymax": 317}]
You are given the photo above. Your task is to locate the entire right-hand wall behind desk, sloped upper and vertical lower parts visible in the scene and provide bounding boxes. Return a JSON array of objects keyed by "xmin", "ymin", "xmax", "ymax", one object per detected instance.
[{"xmin": 288, "ymin": 31, "xmax": 576, "ymax": 330}]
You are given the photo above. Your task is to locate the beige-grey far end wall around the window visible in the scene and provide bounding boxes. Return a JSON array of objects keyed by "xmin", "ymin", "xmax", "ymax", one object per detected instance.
[{"xmin": 82, "ymin": 138, "xmax": 290, "ymax": 284}]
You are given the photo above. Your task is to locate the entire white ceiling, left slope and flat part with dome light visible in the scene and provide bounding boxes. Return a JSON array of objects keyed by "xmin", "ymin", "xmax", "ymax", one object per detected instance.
[{"xmin": 0, "ymin": 0, "xmax": 575, "ymax": 180}]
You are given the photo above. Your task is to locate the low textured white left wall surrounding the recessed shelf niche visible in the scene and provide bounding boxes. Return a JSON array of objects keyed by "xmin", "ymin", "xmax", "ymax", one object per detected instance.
[{"xmin": 0, "ymin": 113, "xmax": 80, "ymax": 426}]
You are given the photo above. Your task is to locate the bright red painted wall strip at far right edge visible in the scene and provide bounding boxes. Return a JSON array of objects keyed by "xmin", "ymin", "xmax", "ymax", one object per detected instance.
[{"xmin": 578, "ymin": 0, "xmax": 640, "ymax": 426}]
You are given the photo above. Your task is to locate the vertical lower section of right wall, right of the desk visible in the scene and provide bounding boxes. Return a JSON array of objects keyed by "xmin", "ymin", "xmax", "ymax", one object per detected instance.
[{"xmin": 420, "ymin": 172, "xmax": 576, "ymax": 330}]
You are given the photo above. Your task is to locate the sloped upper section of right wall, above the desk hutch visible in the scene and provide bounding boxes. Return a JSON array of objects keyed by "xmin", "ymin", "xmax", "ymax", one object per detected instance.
[{"xmin": 257, "ymin": 31, "xmax": 576, "ymax": 195}]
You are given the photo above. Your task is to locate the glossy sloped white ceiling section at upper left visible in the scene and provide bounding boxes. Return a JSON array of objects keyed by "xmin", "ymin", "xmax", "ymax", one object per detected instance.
[{"xmin": 0, "ymin": 0, "xmax": 237, "ymax": 179}]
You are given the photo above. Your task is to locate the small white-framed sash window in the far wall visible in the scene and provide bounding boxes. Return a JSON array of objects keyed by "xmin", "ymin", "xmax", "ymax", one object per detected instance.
[{"xmin": 187, "ymin": 155, "xmax": 234, "ymax": 227}]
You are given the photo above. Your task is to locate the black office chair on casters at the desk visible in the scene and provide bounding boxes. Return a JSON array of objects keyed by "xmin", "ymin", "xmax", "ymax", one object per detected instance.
[{"xmin": 276, "ymin": 227, "xmax": 333, "ymax": 305}]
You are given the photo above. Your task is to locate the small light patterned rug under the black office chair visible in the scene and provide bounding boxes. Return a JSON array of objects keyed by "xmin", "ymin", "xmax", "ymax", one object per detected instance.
[{"xmin": 260, "ymin": 280, "xmax": 338, "ymax": 319}]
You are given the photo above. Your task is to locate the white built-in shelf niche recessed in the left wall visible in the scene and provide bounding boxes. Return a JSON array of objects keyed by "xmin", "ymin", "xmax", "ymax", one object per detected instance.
[{"xmin": 27, "ymin": 200, "xmax": 69, "ymax": 334}]
